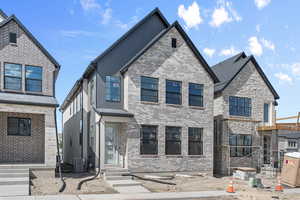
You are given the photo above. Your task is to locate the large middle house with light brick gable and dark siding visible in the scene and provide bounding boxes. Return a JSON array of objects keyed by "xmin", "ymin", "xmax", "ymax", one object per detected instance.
[{"xmin": 60, "ymin": 9, "xmax": 218, "ymax": 174}]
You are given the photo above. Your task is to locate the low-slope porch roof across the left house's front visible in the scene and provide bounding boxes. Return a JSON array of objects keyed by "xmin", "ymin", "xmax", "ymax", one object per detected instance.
[{"xmin": 0, "ymin": 92, "xmax": 58, "ymax": 107}]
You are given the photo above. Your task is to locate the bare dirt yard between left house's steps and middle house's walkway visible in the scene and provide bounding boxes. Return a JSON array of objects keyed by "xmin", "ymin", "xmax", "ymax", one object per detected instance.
[{"xmin": 30, "ymin": 171, "xmax": 116, "ymax": 195}]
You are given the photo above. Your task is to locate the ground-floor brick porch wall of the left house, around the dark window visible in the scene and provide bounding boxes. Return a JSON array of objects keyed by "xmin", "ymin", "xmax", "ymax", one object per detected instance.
[{"xmin": 0, "ymin": 104, "xmax": 56, "ymax": 168}]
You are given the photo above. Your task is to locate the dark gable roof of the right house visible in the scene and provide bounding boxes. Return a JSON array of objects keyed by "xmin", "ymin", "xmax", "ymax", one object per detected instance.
[{"xmin": 212, "ymin": 52, "xmax": 279, "ymax": 99}]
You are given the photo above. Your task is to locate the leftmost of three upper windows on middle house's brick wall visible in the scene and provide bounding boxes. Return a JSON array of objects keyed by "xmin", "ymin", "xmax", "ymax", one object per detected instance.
[{"xmin": 141, "ymin": 76, "xmax": 158, "ymax": 102}]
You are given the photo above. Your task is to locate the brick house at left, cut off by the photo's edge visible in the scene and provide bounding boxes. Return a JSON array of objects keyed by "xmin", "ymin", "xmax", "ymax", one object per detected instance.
[{"xmin": 0, "ymin": 10, "xmax": 60, "ymax": 168}]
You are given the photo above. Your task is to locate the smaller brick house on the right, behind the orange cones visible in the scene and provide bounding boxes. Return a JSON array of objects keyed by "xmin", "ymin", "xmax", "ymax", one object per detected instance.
[{"xmin": 212, "ymin": 52, "xmax": 279, "ymax": 174}]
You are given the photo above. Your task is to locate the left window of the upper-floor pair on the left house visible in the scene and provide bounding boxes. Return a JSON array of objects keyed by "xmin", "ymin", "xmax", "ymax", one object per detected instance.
[{"xmin": 4, "ymin": 63, "xmax": 22, "ymax": 90}]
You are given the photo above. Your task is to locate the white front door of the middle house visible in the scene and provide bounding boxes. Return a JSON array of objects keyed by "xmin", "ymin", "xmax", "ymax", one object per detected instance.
[{"xmin": 105, "ymin": 123, "xmax": 120, "ymax": 165}]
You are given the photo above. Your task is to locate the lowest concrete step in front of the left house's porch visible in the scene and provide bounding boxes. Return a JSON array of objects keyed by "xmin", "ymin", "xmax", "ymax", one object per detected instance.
[{"xmin": 0, "ymin": 183, "xmax": 29, "ymax": 199}]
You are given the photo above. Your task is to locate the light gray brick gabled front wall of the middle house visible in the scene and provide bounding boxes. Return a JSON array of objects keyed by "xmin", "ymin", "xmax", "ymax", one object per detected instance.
[{"xmin": 124, "ymin": 28, "xmax": 214, "ymax": 174}]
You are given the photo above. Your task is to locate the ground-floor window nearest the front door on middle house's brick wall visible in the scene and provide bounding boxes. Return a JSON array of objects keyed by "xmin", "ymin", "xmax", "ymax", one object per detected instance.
[{"xmin": 140, "ymin": 125, "xmax": 158, "ymax": 155}]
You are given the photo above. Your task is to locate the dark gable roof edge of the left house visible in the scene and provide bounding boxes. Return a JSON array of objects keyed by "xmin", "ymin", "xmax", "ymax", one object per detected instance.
[{"xmin": 0, "ymin": 11, "xmax": 60, "ymax": 69}]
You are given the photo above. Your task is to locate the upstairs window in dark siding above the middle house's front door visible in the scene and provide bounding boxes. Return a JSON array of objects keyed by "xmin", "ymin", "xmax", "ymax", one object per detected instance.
[{"xmin": 105, "ymin": 76, "xmax": 121, "ymax": 102}]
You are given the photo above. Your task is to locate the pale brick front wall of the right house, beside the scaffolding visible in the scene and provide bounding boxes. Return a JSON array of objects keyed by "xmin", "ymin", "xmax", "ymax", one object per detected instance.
[{"xmin": 214, "ymin": 62, "xmax": 275, "ymax": 174}]
